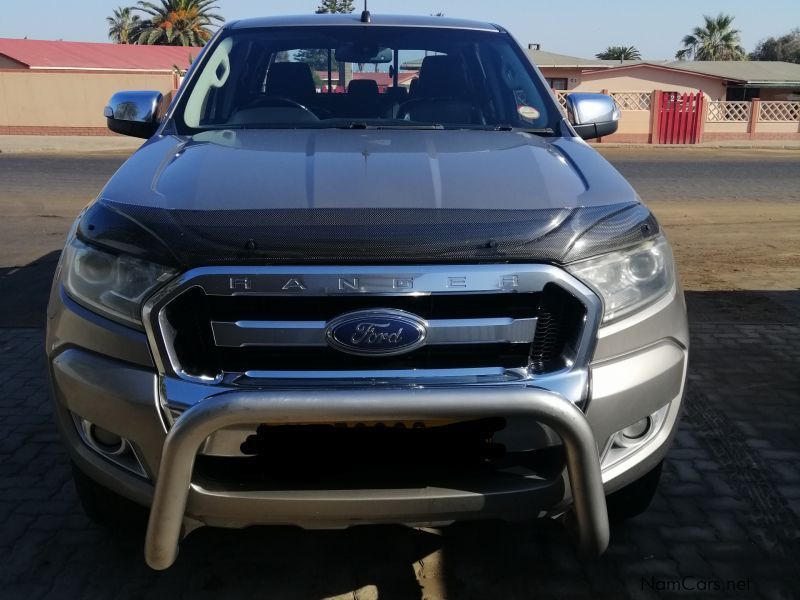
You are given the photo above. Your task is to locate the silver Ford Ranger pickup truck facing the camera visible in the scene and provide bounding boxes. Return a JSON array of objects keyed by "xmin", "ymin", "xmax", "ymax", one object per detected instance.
[{"xmin": 46, "ymin": 12, "xmax": 689, "ymax": 569}]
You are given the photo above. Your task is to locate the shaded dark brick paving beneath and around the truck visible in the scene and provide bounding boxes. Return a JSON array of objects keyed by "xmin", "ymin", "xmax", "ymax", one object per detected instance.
[{"xmin": 0, "ymin": 292, "xmax": 800, "ymax": 600}]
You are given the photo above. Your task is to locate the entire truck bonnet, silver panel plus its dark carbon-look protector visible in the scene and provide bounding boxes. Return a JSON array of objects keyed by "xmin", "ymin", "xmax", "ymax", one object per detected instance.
[{"xmin": 79, "ymin": 129, "xmax": 657, "ymax": 267}]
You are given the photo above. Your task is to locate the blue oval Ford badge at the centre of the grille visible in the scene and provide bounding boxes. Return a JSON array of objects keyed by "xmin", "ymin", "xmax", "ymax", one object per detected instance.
[{"xmin": 325, "ymin": 309, "xmax": 428, "ymax": 356}]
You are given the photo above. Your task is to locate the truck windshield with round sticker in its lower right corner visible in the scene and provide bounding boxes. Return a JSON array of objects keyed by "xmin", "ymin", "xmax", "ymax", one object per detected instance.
[{"xmin": 175, "ymin": 26, "xmax": 559, "ymax": 133}]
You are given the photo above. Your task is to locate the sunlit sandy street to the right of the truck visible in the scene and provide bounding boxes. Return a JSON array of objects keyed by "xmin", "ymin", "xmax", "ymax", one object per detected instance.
[{"xmin": 600, "ymin": 147, "xmax": 800, "ymax": 291}]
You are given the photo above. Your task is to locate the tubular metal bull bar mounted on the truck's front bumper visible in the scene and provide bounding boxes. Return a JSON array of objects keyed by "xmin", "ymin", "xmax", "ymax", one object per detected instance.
[{"xmin": 145, "ymin": 386, "xmax": 609, "ymax": 570}]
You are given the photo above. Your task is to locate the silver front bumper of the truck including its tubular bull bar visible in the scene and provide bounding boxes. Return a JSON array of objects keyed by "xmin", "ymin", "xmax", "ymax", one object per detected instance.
[{"xmin": 48, "ymin": 284, "xmax": 688, "ymax": 569}]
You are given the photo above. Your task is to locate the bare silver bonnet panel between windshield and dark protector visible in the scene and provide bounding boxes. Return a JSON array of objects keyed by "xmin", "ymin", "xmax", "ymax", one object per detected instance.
[{"xmin": 102, "ymin": 129, "xmax": 637, "ymax": 211}]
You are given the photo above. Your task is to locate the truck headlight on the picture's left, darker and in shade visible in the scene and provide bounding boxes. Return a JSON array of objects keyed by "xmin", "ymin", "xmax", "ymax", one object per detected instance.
[{"xmin": 63, "ymin": 239, "xmax": 176, "ymax": 327}]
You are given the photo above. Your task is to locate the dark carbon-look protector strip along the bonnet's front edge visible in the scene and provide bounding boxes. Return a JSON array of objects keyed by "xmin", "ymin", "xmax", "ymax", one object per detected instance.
[{"xmin": 78, "ymin": 199, "xmax": 659, "ymax": 269}]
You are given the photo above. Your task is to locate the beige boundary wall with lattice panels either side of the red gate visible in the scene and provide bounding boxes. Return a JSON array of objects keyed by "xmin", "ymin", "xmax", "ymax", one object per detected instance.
[{"xmin": 553, "ymin": 90, "xmax": 800, "ymax": 143}]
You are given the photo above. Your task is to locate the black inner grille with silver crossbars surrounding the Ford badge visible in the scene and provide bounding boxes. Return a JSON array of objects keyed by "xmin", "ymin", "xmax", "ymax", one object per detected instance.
[{"xmin": 152, "ymin": 264, "xmax": 587, "ymax": 381}]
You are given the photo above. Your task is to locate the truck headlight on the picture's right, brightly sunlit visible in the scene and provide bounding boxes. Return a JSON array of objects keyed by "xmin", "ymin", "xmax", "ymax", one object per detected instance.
[{"xmin": 568, "ymin": 236, "xmax": 675, "ymax": 325}]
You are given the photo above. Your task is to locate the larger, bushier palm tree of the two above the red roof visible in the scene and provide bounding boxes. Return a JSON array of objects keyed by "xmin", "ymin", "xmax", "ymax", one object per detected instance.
[{"xmin": 136, "ymin": 0, "xmax": 224, "ymax": 46}]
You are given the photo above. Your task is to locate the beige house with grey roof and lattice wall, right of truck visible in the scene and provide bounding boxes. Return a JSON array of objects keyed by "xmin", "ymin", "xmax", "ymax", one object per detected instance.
[{"xmin": 528, "ymin": 47, "xmax": 800, "ymax": 143}]
